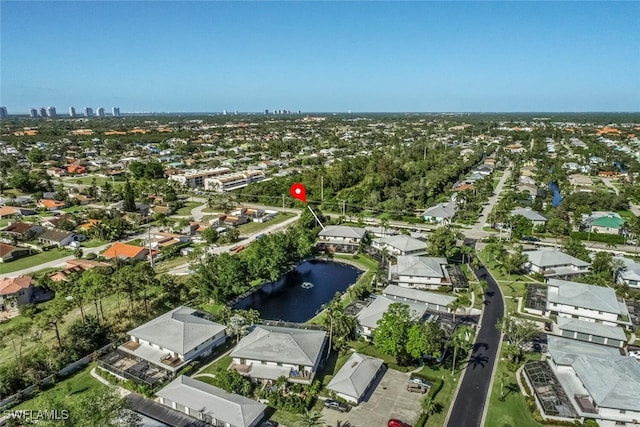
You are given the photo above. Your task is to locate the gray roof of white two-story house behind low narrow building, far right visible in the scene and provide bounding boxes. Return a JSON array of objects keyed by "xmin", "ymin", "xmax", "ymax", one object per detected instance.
[{"xmin": 547, "ymin": 279, "xmax": 622, "ymax": 314}]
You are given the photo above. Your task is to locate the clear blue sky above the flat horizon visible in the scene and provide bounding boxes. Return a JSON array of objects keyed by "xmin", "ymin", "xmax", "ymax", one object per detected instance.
[{"xmin": 0, "ymin": 0, "xmax": 640, "ymax": 113}]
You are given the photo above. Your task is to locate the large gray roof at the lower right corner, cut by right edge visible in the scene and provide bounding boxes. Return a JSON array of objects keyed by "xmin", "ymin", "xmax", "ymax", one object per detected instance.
[{"xmin": 548, "ymin": 335, "xmax": 640, "ymax": 411}]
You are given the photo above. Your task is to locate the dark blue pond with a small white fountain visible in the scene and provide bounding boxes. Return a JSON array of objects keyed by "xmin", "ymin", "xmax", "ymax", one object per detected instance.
[{"xmin": 234, "ymin": 261, "xmax": 362, "ymax": 323}]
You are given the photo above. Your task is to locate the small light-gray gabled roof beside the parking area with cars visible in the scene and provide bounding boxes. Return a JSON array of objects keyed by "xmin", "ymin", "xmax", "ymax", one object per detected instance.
[{"xmin": 327, "ymin": 353, "xmax": 384, "ymax": 400}]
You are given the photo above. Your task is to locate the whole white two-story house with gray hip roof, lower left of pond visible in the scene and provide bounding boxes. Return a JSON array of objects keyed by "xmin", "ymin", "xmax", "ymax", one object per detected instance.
[{"xmin": 118, "ymin": 306, "xmax": 227, "ymax": 372}]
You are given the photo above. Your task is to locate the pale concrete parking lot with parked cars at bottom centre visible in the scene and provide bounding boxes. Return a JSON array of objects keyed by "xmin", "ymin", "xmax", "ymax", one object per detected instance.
[{"xmin": 322, "ymin": 369, "xmax": 424, "ymax": 427}]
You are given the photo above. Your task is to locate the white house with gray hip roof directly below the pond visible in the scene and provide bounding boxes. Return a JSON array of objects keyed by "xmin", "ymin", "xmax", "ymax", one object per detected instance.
[{"xmin": 231, "ymin": 325, "xmax": 327, "ymax": 384}]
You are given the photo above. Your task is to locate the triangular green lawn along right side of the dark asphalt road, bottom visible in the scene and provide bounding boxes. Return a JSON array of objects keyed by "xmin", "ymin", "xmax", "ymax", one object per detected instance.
[{"xmin": 485, "ymin": 349, "xmax": 564, "ymax": 427}]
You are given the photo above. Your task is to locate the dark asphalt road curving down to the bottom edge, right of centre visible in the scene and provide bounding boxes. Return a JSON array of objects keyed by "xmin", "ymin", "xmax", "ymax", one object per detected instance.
[{"xmin": 447, "ymin": 241, "xmax": 504, "ymax": 427}]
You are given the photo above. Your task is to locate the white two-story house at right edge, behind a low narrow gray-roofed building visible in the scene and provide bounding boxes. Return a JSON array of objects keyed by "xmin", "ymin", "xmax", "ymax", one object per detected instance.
[{"xmin": 545, "ymin": 279, "xmax": 630, "ymax": 326}]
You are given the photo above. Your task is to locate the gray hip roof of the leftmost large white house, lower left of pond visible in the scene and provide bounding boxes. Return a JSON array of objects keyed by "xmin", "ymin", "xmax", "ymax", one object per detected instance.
[{"xmin": 128, "ymin": 306, "xmax": 225, "ymax": 354}]
